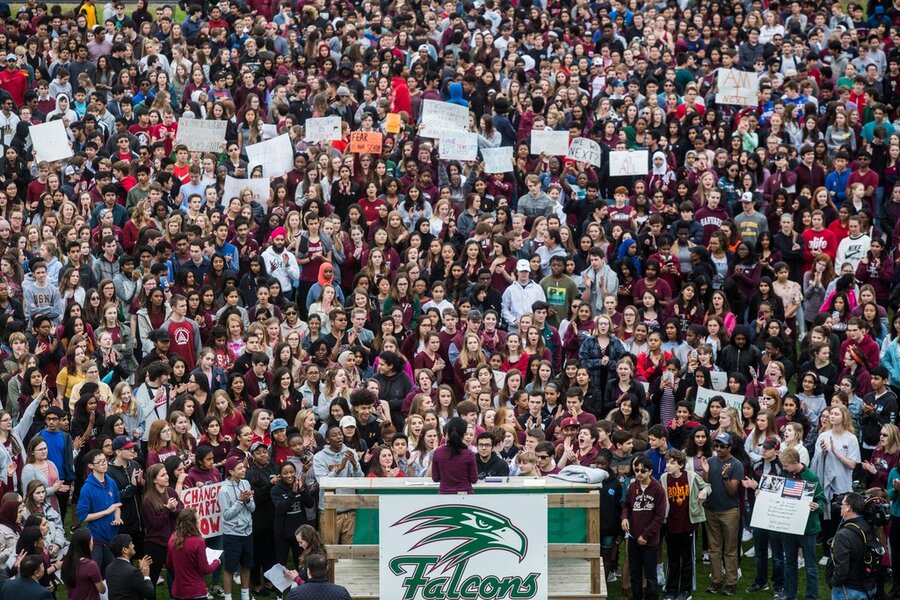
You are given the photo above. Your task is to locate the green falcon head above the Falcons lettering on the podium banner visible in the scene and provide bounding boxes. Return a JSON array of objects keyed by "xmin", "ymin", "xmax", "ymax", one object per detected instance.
[{"xmin": 394, "ymin": 505, "xmax": 528, "ymax": 572}]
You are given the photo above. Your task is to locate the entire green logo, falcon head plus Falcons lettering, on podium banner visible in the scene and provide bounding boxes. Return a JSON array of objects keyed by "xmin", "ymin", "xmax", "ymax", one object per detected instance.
[{"xmin": 389, "ymin": 505, "xmax": 539, "ymax": 600}]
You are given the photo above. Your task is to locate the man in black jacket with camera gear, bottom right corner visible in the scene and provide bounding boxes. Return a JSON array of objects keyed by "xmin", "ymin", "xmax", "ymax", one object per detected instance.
[{"xmin": 831, "ymin": 492, "xmax": 877, "ymax": 600}]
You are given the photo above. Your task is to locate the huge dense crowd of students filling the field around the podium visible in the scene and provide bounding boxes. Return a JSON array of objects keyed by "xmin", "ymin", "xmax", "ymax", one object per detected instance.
[{"xmin": 0, "ymin": 0, "xmax": 900, "ymax": 600}]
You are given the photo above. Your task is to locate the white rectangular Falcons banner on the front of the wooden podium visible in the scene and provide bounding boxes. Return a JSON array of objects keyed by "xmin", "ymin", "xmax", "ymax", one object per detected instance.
[{"xmin": 378, "ymin": 494, "xmax": 549, "ymax": 600}]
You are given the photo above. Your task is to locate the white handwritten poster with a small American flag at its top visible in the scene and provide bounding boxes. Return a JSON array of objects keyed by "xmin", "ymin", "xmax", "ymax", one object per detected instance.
[{"xmin": 750, "ymin": 475, "xmax": 816, "ymax": 535}]
